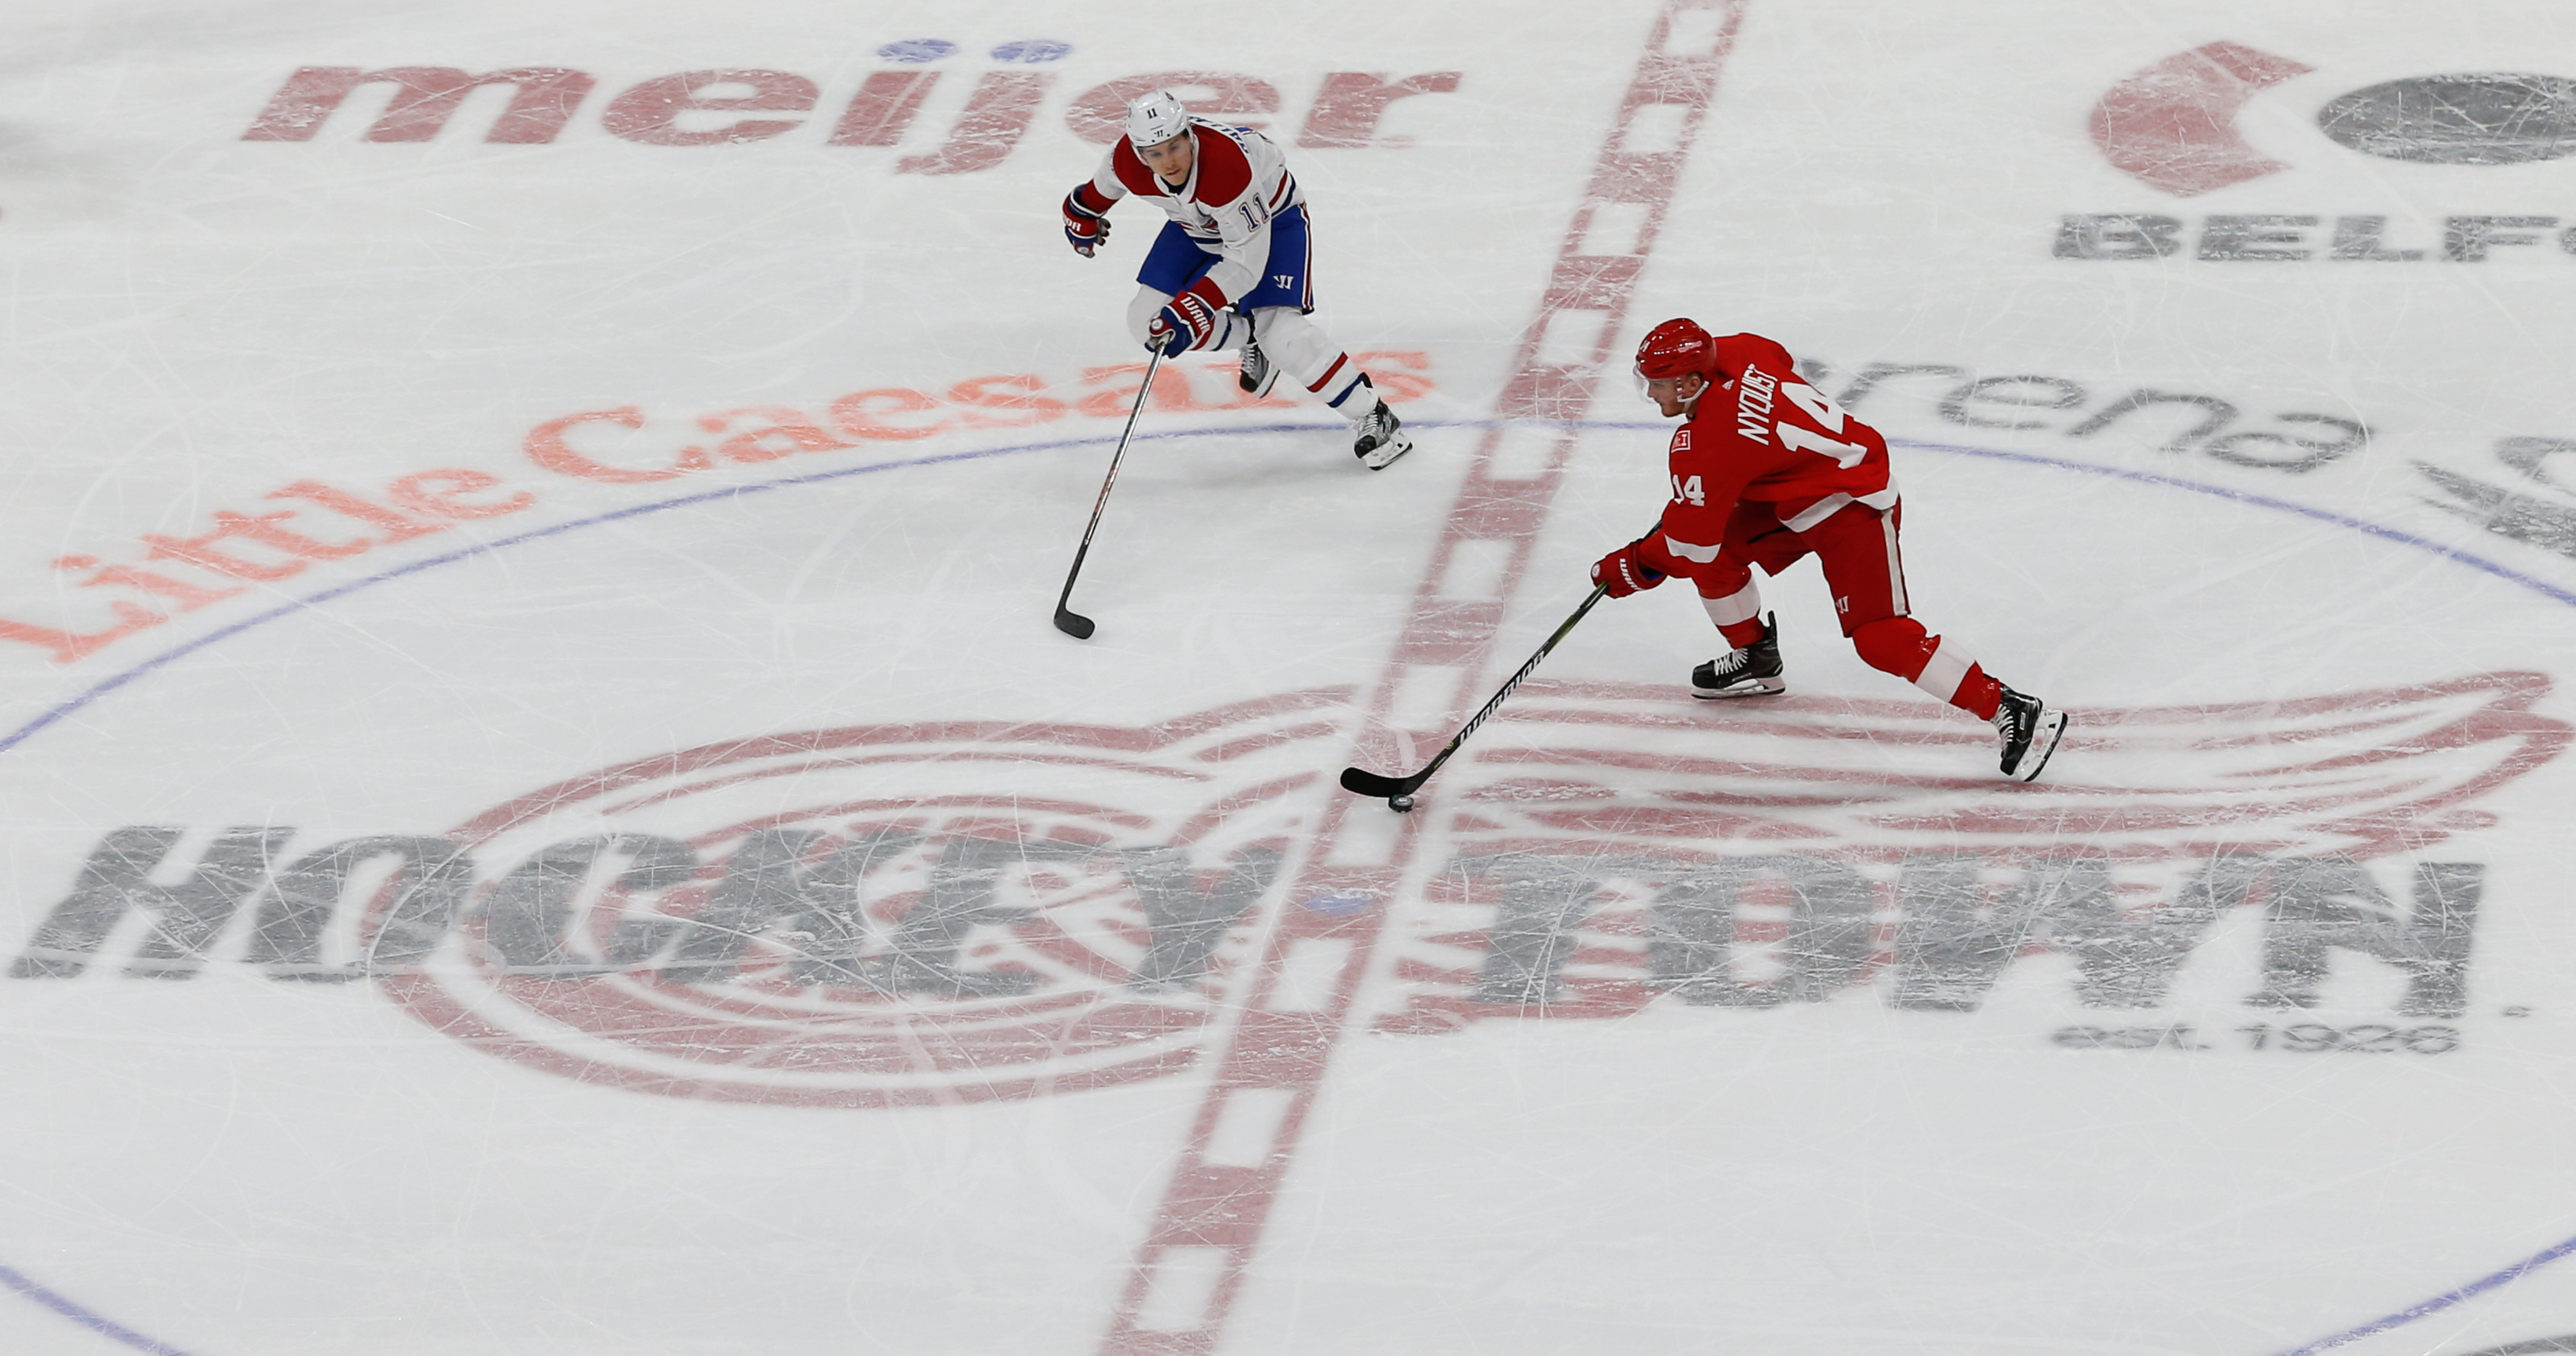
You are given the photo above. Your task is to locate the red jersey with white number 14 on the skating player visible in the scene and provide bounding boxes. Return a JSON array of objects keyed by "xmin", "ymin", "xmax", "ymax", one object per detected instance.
[{"xmin": 1638, "ymin": 335, "xmax": 1896, "ymax": 575}]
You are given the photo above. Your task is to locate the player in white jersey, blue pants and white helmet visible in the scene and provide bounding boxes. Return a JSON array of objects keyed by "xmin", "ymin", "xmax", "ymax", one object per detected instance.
[{"xmin": 1064, "ymin": 90, "xmax": 1414, "ymax": 469}]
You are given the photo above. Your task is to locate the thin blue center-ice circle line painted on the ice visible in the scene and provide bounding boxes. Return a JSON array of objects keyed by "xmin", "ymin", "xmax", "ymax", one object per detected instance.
[{"xmin": 0, "ymin": 420, "xmax": 2576, "ymax": 1356}]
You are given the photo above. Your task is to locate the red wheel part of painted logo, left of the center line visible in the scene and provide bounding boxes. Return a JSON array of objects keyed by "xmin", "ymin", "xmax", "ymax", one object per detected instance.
[{"xmin": 381, "ymin": 694, "xmax": 1337, "ymax": 1106}]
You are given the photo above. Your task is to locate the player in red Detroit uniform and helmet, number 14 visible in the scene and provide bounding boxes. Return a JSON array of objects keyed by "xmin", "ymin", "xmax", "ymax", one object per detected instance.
[{"xmin": 1592, "ymin": 319, "xmax": 2066, "ymax": 781}]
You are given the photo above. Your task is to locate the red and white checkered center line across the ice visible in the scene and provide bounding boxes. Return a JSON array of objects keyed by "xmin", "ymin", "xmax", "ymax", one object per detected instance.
[{"xmin": 1100, "ymin": 0, "xmax": 1746, "ymax": 1356}]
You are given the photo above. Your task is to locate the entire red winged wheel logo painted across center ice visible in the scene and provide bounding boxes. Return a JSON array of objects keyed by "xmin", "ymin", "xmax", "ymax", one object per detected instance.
[{"xmin": 379, "ymin": 673, "xmax": 2571, "ymax": 1106}]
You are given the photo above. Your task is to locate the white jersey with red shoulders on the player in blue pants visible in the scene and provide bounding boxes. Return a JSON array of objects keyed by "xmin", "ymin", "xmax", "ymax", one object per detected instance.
[{"xmin": 1074, "ymin": 116, "xmax": 1306, "ymax": 302}]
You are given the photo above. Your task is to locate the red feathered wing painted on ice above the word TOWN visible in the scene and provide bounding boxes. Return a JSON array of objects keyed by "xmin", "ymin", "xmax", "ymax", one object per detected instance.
[{"xmin": 1450, "ymin": 673, "xmax": 2571, "ymax": 861}]
